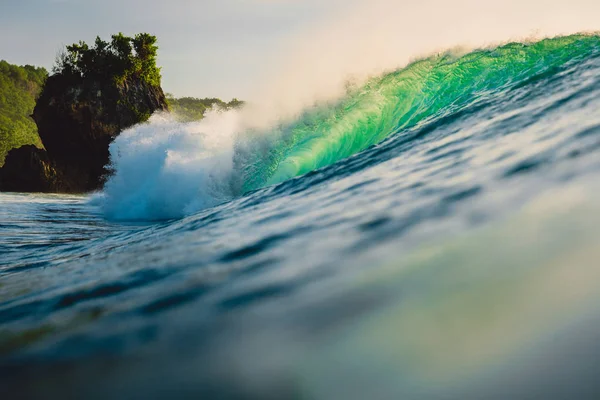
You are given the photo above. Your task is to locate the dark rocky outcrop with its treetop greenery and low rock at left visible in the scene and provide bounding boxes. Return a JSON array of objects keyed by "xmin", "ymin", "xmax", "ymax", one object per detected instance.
[{"xmin": 0, "ymin": 34, "xmax": 169, "ymax": 193}]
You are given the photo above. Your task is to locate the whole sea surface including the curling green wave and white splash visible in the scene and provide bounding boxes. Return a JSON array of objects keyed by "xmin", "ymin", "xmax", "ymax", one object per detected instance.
[{"xmin": 0, "ymin": 35, "xmax": 600, "ymax": 399}]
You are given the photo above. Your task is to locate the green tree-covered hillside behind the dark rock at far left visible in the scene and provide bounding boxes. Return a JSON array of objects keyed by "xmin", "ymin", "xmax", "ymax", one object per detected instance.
[{"xmin": 0, "ymin": 61, "xmax": 48, "ymax": 166}]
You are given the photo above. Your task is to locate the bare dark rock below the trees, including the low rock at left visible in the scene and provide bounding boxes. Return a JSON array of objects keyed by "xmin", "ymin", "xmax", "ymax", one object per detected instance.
[{"xmin": 0, "ymin": 75, "xmax": 168, "ymax": 193}]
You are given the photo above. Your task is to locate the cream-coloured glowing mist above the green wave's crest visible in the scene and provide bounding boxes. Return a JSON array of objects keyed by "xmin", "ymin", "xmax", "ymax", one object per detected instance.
[{"xmin": 240, "ymin": 0, "xmax": 600, "ymax": 127}]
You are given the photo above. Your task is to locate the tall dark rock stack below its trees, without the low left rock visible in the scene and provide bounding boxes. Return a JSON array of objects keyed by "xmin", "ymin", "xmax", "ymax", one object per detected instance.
[{"xmin": 33, "ymin": 75, "xmax": 167, "ymax": 192}]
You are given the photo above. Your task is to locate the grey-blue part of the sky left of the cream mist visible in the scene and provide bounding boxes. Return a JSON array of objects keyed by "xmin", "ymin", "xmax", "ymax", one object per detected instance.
[{"xmin": 0, "ymin": 0, "xmax": 352, "ymax": 98}]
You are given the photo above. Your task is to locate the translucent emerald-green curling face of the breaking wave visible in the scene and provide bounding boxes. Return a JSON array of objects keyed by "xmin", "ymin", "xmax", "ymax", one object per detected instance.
[{"xmin": 238, "ymin": 35, "xmax": 600, "ymax": 192}]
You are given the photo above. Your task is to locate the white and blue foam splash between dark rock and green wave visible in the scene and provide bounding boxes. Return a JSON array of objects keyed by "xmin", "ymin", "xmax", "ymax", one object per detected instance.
[{"xmin": 96, "ymin": 111, "xmax": 239, "ymax": 220}]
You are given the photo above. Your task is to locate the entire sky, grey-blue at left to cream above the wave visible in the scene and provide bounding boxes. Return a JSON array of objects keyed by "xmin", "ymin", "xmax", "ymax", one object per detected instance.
[{"xmin": 0, "ymin": 0, "xmax": 600, "ymax": 103}]
